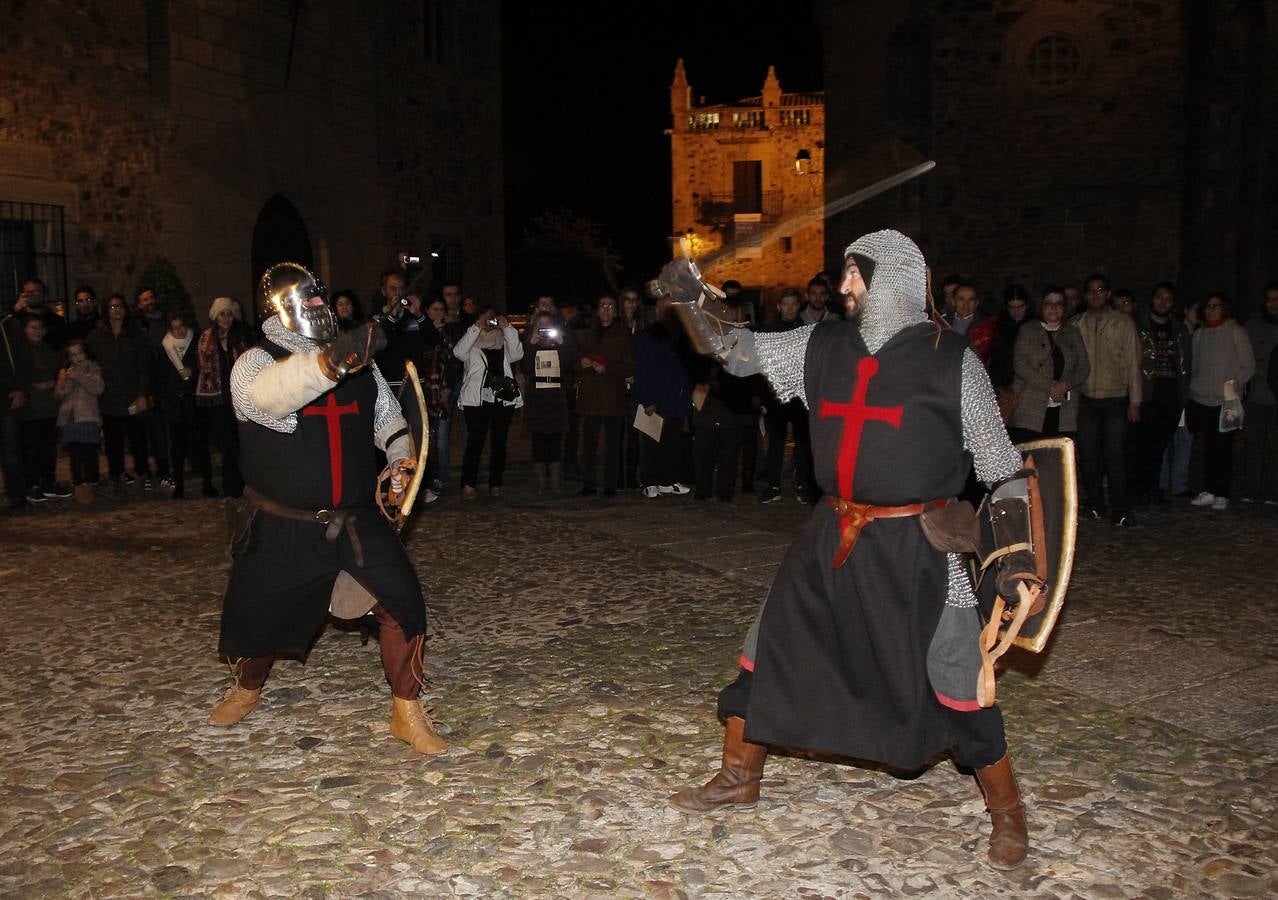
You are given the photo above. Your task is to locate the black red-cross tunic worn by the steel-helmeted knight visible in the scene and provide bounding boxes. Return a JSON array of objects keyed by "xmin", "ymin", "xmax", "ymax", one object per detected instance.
[{"xmin": 219, "ymin": 345, "xmax": 426, "ymax": 657}]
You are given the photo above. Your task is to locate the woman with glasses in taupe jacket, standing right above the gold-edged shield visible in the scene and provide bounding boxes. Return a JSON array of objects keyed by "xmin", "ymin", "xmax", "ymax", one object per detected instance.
[{"xmin": 1007, "ymin": 288, "xmax": 1091, "ymax": 444}]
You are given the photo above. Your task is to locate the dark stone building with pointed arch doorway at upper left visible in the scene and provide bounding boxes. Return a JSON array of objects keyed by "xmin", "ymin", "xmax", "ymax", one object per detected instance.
[{"xmin": 0, "ymin": 0, "xmax": 505, "ymax": 319}]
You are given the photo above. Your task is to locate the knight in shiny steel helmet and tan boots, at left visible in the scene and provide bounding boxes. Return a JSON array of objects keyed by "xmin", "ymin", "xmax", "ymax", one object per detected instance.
[{"xmin": 208, "ymin": 262, "xmax": 447, "ymax": 753}]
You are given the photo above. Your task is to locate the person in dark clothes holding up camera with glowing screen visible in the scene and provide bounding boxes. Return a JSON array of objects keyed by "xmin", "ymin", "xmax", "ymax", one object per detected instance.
[{"xmin": 521, "ymin": 312, "xmax": 576, "ymax": 493}]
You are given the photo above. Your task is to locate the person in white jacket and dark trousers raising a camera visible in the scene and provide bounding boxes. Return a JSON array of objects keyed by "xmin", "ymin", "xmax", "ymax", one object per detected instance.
[{"xmin": 452, "ymin": 306, "xmax": 524, "ymax": 500}]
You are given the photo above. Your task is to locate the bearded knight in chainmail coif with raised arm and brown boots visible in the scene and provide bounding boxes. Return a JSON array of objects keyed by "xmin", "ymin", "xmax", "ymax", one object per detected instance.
[{"xmin": 658, "ymin": 230, "xmax": 1042, "ymax": 868}]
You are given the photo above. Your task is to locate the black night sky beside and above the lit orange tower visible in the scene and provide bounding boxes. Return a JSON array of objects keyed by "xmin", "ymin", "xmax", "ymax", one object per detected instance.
[{"xmin": 502, "ymin": 0, "xmax": 822, "ymax": 288}]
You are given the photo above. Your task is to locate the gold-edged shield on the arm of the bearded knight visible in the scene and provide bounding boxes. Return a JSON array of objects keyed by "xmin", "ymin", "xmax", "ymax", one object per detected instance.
[{"xmin": 970, "ymin": 437, "xmax": 1079, "ymax": 653}]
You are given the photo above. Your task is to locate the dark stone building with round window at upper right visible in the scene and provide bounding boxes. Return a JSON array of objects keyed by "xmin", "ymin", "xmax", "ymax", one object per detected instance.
[{"xmin": 818, "ymin": 0, "xmax": 1278, "ymax": 317}]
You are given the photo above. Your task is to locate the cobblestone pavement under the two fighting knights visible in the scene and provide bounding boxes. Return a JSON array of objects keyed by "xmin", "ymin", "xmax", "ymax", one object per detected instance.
[{"xmin": 0, "ymin": 470, "xmax": 1278, "ymax": 897}]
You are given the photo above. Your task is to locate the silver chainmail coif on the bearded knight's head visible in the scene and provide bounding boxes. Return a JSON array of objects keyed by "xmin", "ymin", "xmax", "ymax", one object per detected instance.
[{"xmin": 843, "ymin": 229, "xmax": 928, "ymax": 353}]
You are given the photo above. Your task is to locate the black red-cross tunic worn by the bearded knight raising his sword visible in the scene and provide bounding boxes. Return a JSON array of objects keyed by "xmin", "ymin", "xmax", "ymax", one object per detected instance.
[{"xmin": 741, "ymin": 322, "xmax": 986, "ymax": 768}]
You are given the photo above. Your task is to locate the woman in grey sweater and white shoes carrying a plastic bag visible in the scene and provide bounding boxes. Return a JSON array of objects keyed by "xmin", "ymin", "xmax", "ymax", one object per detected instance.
[{"xmin": 1185, "ymin": 293, "xmax": 1256, "ymax": 510}]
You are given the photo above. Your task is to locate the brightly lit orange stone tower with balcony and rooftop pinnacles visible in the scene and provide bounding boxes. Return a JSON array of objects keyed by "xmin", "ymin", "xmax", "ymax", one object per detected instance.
[{"xmin": 670, "ymin": 60, "xmax": 826, "ymax": 314}]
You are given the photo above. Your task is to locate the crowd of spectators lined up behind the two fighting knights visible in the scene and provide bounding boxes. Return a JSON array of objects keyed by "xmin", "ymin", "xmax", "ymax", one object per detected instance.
[{"xmin": 7, "ymin": 270, "xmax": 1278, "ymax": 528}]
